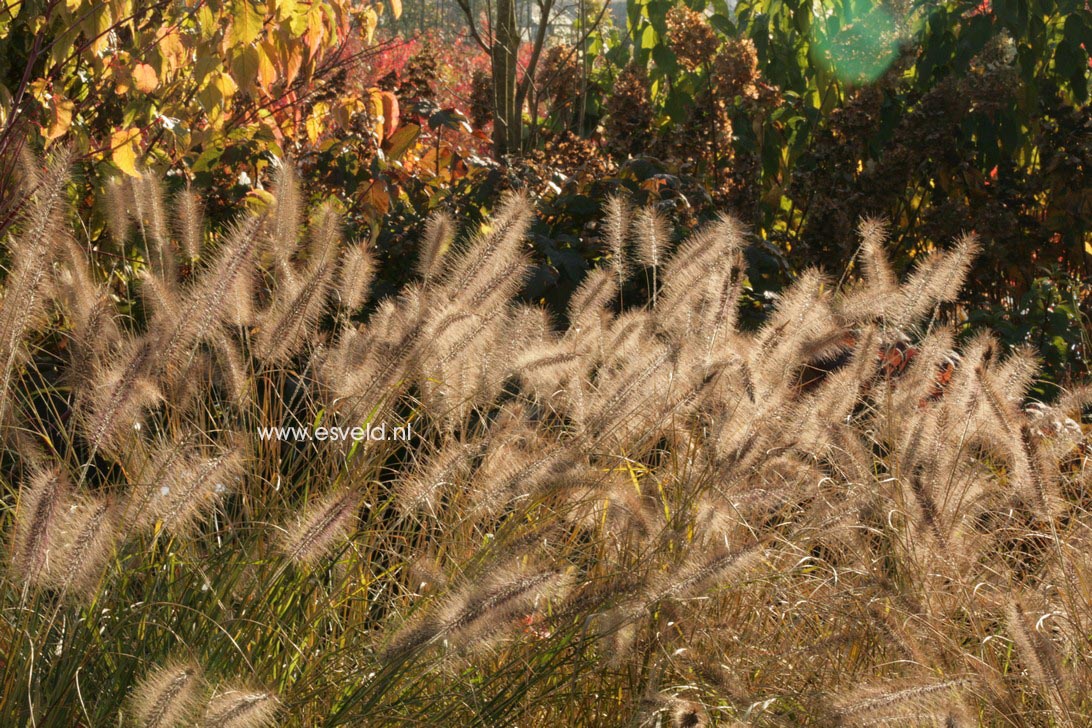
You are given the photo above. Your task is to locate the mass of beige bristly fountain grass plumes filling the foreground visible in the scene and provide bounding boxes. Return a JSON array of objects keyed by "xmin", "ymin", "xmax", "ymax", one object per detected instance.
[{"xmin": 0, "ymin": 152, "xmax": 1092, "ymax": 728}]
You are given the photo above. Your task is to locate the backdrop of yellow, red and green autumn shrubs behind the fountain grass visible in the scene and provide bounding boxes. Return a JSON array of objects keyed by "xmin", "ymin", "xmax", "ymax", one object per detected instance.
[{"xmin": 0, "ymin": 0, "xmax": 1092, "ymax": 394}]
